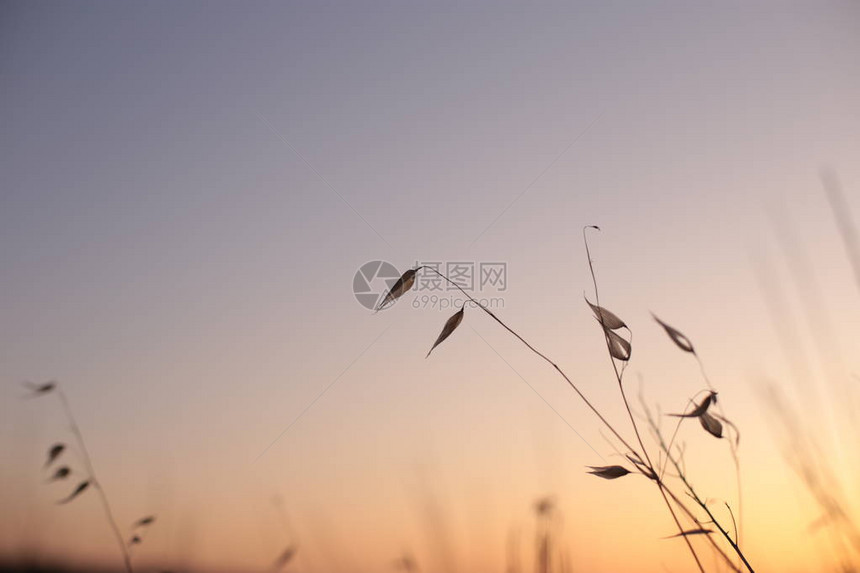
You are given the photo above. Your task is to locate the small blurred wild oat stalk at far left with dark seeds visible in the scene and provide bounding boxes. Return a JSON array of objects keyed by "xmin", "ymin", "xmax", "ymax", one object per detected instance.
[{"xmin": 24, "ymin": 381, "xmax": 155, "ymax": 573}]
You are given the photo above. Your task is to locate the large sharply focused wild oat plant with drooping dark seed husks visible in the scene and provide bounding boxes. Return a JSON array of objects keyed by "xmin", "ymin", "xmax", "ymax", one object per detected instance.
[{"xmin": 376, "ymin": 226, "xmax": 754, "ymax": 573}]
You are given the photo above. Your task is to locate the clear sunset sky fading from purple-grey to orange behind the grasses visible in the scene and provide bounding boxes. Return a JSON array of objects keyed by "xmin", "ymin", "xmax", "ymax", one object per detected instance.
[{"xmin": 0, "ymin": 1, "xmax": 860, "ymax": 573}]
